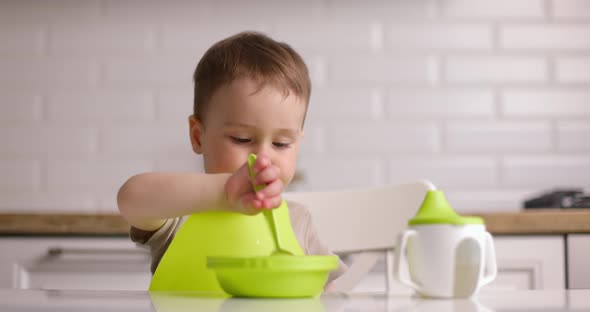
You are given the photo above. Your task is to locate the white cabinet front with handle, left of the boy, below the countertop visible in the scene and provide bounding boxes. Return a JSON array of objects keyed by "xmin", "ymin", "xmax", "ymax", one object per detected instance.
[{"xmin": 0, "ymin": 237, "xmax": 151, "ymax": 290}]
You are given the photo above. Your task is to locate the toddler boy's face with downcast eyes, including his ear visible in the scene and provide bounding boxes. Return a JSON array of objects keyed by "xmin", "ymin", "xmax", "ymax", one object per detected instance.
[{"xmin": 189, "ymin": 78, "xmax": 305, "ymax": 185}]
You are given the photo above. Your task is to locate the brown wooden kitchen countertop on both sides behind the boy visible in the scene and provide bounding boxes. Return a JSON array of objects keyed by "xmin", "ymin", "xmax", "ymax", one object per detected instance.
[{"xmin": 0, "ymin": 209, "xmax": 590, "ymax": 235}]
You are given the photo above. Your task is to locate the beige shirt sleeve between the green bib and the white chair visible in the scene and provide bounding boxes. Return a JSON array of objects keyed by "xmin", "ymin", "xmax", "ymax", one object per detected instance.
[{"xmin": 289, "ymin": 202, "xmax": 347, "ymax": 283}]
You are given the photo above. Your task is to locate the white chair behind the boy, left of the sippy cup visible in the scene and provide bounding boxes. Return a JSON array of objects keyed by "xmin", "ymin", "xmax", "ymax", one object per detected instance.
[{"xmin": 284, "ymin": 181, "xmax": 435, "ymax": 292}]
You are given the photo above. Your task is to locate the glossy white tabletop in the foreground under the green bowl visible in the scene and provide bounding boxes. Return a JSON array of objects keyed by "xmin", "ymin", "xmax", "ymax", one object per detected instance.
[{"xmin": 0, "ymin": 289, "xmax": 590, "ymax": 312}]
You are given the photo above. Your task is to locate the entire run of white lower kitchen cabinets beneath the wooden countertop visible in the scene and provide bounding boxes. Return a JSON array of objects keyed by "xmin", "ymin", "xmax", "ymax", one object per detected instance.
[{"xmin": 0, "ymin": 235, "xmax": 572, "ymax": 293}]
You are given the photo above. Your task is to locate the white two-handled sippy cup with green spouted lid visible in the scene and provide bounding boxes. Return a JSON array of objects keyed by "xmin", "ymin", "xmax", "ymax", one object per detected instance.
[{"xmin": 394, "ymin": 190, "xmax": 497, "ymax": 298}]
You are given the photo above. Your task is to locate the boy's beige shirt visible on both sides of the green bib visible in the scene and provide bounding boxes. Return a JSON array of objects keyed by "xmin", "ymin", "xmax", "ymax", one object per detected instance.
[{"xmin": 130, "ymin": 202, "xmax": 346, "ymax": 283}]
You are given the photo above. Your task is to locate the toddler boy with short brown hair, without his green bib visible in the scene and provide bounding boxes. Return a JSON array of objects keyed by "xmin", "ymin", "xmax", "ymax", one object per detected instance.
[{"xmin": 117, "ymin": 32, "xmax": 345, "ymax": 288}]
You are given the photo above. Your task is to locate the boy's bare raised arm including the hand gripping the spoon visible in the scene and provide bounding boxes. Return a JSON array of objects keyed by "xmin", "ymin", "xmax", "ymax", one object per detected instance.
[{"xmin": 117, "ymin": 155, "xmax": 283, "ymax": 231}]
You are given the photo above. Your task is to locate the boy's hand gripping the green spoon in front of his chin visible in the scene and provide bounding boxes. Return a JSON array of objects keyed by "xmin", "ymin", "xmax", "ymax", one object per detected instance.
[{"xmin": 225, "ymin": 153, "xmax": 283, "ymax": 215}]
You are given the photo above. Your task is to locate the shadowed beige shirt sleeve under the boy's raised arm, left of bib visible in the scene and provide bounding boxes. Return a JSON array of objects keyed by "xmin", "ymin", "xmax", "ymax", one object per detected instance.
[{"xmin": 129, "ymin": 217, "xmax": 186, "ymax": 274}]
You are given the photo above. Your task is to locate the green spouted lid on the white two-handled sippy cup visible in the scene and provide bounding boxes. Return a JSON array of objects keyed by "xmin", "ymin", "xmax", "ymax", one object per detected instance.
[{"xmin": 408, "ymin": 190, "xmax": 484, "ymax": 225}]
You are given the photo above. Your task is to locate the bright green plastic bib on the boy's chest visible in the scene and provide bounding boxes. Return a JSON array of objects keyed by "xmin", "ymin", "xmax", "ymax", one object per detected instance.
[{"xmin": 150, "ymin": 201, "xmax": 304, "ymax": 295}]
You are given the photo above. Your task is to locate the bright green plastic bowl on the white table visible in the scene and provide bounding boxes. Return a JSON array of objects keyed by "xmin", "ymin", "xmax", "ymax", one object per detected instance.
[{"xmin": 207, "ymin": 255, "xmax": 338, "ymax": 298}]
